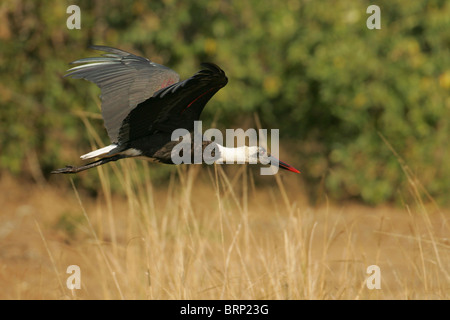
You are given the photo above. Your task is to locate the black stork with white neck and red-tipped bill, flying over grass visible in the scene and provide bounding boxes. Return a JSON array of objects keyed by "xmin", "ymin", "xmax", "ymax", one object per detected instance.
[{"xmin": 52, "ymin": 46, "xmax": 300, "ymax": 173}]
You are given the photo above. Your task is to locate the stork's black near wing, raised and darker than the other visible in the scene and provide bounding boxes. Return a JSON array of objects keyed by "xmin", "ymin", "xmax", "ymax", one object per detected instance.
[{"xmin": 119, "ymin": 63, "xmax": 228, "ymax": 143}]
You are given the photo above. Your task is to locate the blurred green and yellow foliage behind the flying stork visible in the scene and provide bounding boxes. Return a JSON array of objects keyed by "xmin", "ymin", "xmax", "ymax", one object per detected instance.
[{"xmin": 0, "ymin": 0, "xmax": 450, "ymax": 204}]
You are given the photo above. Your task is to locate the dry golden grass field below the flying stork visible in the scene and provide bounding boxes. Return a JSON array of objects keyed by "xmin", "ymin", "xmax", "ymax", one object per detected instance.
[{"xmin": 0, "ymin": 160, "xmax": 450, "ymax": 299}]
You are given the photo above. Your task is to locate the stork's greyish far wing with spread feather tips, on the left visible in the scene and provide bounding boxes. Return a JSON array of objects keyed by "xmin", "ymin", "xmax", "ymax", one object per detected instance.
[{"xmin": 66, "ymin": 46, "xmax": 180, "ymax": 143}]
